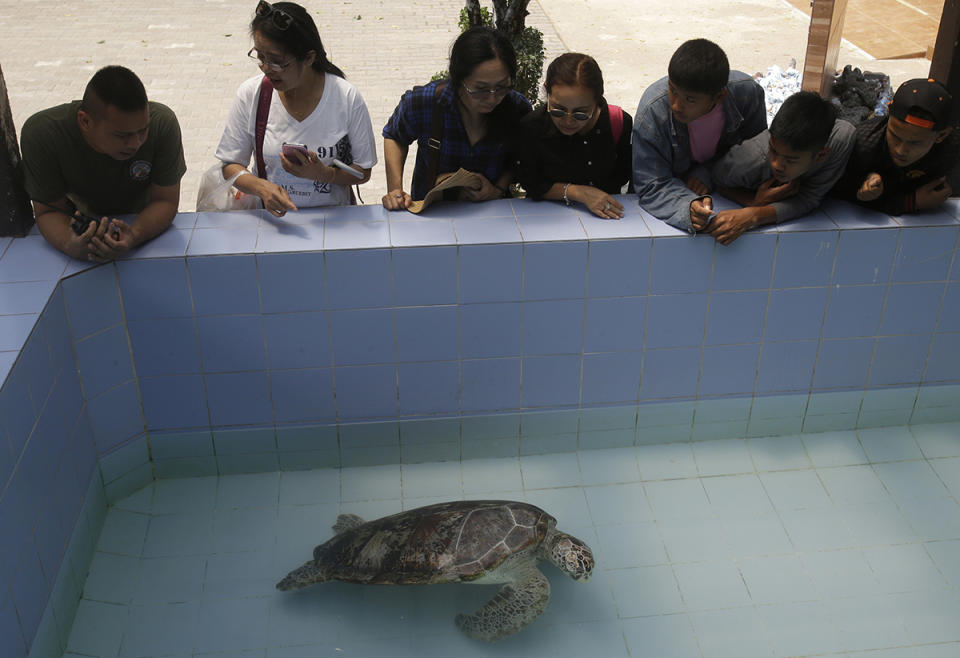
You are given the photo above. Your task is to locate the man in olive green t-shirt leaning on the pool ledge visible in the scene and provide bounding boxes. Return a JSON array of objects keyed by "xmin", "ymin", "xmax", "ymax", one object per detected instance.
[{"xmin": 20, "ymin": 66, "xmax": 187, "ymax": 262}]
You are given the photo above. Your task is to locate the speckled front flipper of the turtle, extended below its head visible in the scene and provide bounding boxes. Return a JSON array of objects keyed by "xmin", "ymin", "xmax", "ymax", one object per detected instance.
[{"xmin": 456, "ymin": 566, "xmax": 550, "ymax": 642}]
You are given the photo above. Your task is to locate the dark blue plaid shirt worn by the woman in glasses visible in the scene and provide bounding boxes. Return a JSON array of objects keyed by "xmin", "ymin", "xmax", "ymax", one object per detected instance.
[{"xmin": 383, "ymin": 81, "xmax": 530, "ymax": 199}]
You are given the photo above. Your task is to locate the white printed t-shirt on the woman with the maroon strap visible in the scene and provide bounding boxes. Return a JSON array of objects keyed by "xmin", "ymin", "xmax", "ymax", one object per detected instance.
[{"xmin": 217, "ymin": 73, "xmax": 377, "ymax": 207}]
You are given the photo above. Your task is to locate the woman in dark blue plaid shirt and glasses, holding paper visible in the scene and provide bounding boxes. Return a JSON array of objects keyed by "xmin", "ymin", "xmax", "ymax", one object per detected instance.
[{"xmin": 383, "ymin": 27, "xmax": 530, "ymax": 210}]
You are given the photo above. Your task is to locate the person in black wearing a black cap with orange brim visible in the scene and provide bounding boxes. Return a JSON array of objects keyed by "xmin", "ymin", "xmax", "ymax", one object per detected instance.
[{"xmin": 835, "ymin": 78, "xmax": 960, "ymax": 215}]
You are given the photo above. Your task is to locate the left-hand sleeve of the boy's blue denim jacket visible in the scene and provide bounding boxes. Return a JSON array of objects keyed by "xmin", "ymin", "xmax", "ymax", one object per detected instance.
[{"xmin": 633, "ymin": 80, "xmax": 697, "ymax": 233}]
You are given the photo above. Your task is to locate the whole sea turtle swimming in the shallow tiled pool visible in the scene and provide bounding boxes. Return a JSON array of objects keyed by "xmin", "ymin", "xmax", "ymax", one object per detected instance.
[{"xmin": 277, "ymin": 500, "xmax": 593, "ymax": 642}]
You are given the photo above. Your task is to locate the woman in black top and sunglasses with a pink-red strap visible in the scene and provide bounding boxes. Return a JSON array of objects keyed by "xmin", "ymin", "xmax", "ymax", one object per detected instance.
[{"xmin": 517, "ymin": 53, "xmax": 633, "ymax": 219}]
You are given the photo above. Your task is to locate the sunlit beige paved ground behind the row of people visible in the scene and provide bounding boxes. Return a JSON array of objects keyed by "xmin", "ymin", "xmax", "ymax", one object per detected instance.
[{"xmin": 0, "ymin": 0, "xmax": 929, "ymax": 210}]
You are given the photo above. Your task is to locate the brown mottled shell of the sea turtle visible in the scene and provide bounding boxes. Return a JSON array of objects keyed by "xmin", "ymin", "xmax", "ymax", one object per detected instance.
[{"xmin": 313, "ymin": 500, "xmax": 557, "ymax": 585}]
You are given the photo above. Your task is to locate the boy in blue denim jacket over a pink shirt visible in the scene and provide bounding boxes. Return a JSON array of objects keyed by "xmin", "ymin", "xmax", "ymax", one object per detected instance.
[{"xmin": 633, "ymin": 39, "xmax": 767, "ymax": 233}]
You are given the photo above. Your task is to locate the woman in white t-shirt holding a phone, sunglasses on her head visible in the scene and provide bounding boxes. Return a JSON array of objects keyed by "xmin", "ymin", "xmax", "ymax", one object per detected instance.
[{"xmin": 216, "ymin": 0, "xmax": 377, "ymax": 217}]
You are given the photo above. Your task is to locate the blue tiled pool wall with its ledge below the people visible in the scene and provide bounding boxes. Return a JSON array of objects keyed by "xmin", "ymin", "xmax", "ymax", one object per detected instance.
[{"xmin": 0, "ymin": 197, "xmax": 960, "ymax": 656}]
